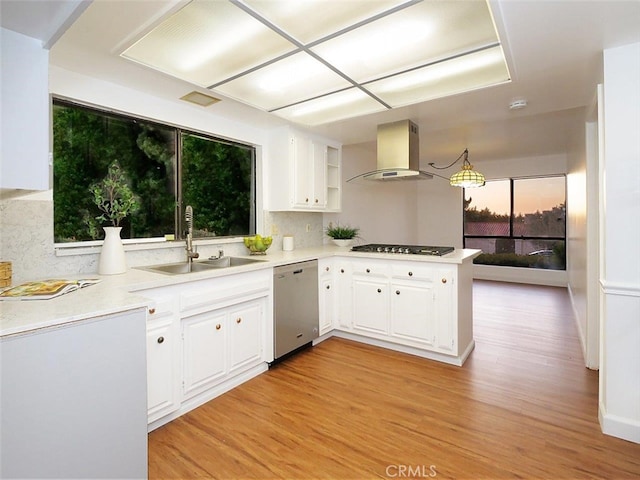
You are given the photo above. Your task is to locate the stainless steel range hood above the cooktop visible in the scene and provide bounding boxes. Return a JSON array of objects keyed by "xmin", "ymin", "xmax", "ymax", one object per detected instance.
[{"xmin": 347, "ymin": 120, "xmax": 433, "ymax": 182}]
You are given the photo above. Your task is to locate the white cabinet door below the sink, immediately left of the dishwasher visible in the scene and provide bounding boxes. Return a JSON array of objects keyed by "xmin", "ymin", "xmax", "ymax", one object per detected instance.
[{"xmin": 228, "ymin": 300, "xmax": 264, "ymax": 373}]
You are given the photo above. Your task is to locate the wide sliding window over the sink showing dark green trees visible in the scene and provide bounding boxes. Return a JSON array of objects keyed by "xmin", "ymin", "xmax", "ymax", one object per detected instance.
[{"xmin": 53, "ymin": 99, "xmax": 256, "ymax": 243}]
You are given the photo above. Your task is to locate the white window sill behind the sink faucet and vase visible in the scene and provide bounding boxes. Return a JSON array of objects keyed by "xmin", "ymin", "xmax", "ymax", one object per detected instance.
[{"xmin": 53, "ymin": 237, "xmax": 244, "ymax": 257}]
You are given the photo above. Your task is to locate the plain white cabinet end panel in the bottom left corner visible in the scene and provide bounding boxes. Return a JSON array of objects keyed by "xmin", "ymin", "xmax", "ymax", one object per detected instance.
[{"xmin": 0, "ymin": 308, "xmax": 147, "ymax": 479}]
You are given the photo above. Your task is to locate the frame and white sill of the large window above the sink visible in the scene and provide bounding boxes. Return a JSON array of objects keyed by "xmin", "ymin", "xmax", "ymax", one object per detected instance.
[{"xmin": 50, "ymin": 95, "xmax": 259, "ymax": 248}]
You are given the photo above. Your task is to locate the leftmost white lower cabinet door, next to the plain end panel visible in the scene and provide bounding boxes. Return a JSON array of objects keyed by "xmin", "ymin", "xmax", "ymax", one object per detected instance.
[{"xmin": 147, "ymin": 316, "xmax": 179, "ymax": 423}]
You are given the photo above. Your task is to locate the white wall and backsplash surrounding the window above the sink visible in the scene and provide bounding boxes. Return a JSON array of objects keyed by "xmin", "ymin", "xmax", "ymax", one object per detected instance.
[{"xmin": 0, "ymin": 66, "xmax": 323, "ymax": 284}]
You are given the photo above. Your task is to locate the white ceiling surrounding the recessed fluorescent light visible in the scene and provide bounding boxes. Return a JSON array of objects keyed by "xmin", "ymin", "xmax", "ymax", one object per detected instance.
[{"xmin": 0, "ymin": 0, "xmax": 640, "ymax": 165}]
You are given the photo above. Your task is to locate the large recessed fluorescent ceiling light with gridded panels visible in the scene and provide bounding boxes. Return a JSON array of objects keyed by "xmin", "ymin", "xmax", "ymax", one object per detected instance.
[{"xmin": 122, "ymin": 0, "xmax": 510, "ymax": 125}]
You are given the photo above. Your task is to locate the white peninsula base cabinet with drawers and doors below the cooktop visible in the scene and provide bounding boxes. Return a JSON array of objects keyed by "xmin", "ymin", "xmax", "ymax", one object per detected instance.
[{"xmin": 334, "ymin": 257, "xmax": 473, "ymax": 363}]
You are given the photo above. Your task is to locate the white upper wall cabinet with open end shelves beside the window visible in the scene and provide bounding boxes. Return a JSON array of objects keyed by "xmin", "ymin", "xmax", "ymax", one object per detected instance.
[{"xmin": 265, "ymin": 128, "xmax": 341, "ymax": 212}]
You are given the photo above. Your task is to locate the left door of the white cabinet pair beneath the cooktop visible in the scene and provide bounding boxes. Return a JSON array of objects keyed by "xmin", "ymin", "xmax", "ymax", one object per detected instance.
[{"xmin": 353, "ymin": 275, "xmax": 389, "ymax": 334}]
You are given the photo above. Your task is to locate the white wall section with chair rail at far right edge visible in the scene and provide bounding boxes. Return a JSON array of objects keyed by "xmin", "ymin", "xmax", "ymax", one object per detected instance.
[{"xmin": 599, "ymin": 43, "xmax": 640, "ymax": 443}]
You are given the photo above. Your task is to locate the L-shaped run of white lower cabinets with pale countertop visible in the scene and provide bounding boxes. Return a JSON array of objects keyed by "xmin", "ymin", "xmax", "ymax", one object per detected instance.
[{"xmin": 0, "ymin": 246, "xmax": 480, "ymax": 478}]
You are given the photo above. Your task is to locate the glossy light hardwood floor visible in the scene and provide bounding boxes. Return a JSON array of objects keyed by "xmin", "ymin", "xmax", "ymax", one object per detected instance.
[{"xmin": 149, "ymin": 281, "xmax": 640, "ymax": 479}]
